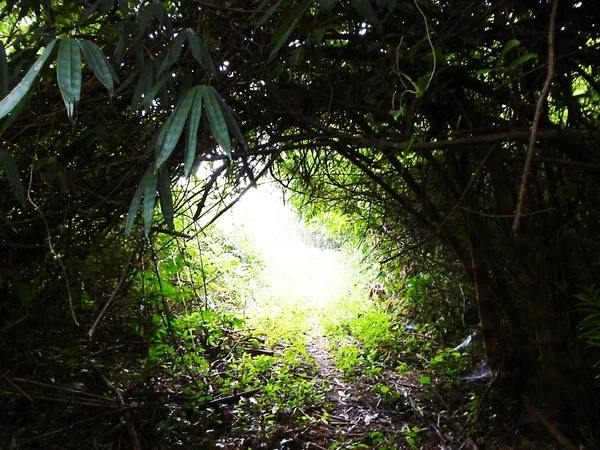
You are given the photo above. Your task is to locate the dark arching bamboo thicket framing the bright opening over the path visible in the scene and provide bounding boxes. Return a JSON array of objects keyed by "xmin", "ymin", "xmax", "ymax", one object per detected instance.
[{"xmin": 0, "ymin": 0, "xmax": 600, "ymax": 448}]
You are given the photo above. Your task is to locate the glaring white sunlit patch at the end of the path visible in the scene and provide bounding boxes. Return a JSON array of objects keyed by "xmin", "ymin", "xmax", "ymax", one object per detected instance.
[{"xmin": 219, "ymin": 186, "xmax": 365, "ymax": 344}]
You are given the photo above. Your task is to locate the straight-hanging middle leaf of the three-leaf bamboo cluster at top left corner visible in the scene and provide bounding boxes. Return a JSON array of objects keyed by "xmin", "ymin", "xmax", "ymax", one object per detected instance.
[{"xmin": 56, "ymin": 38, "xmax": 81, "ymax": 119}]
